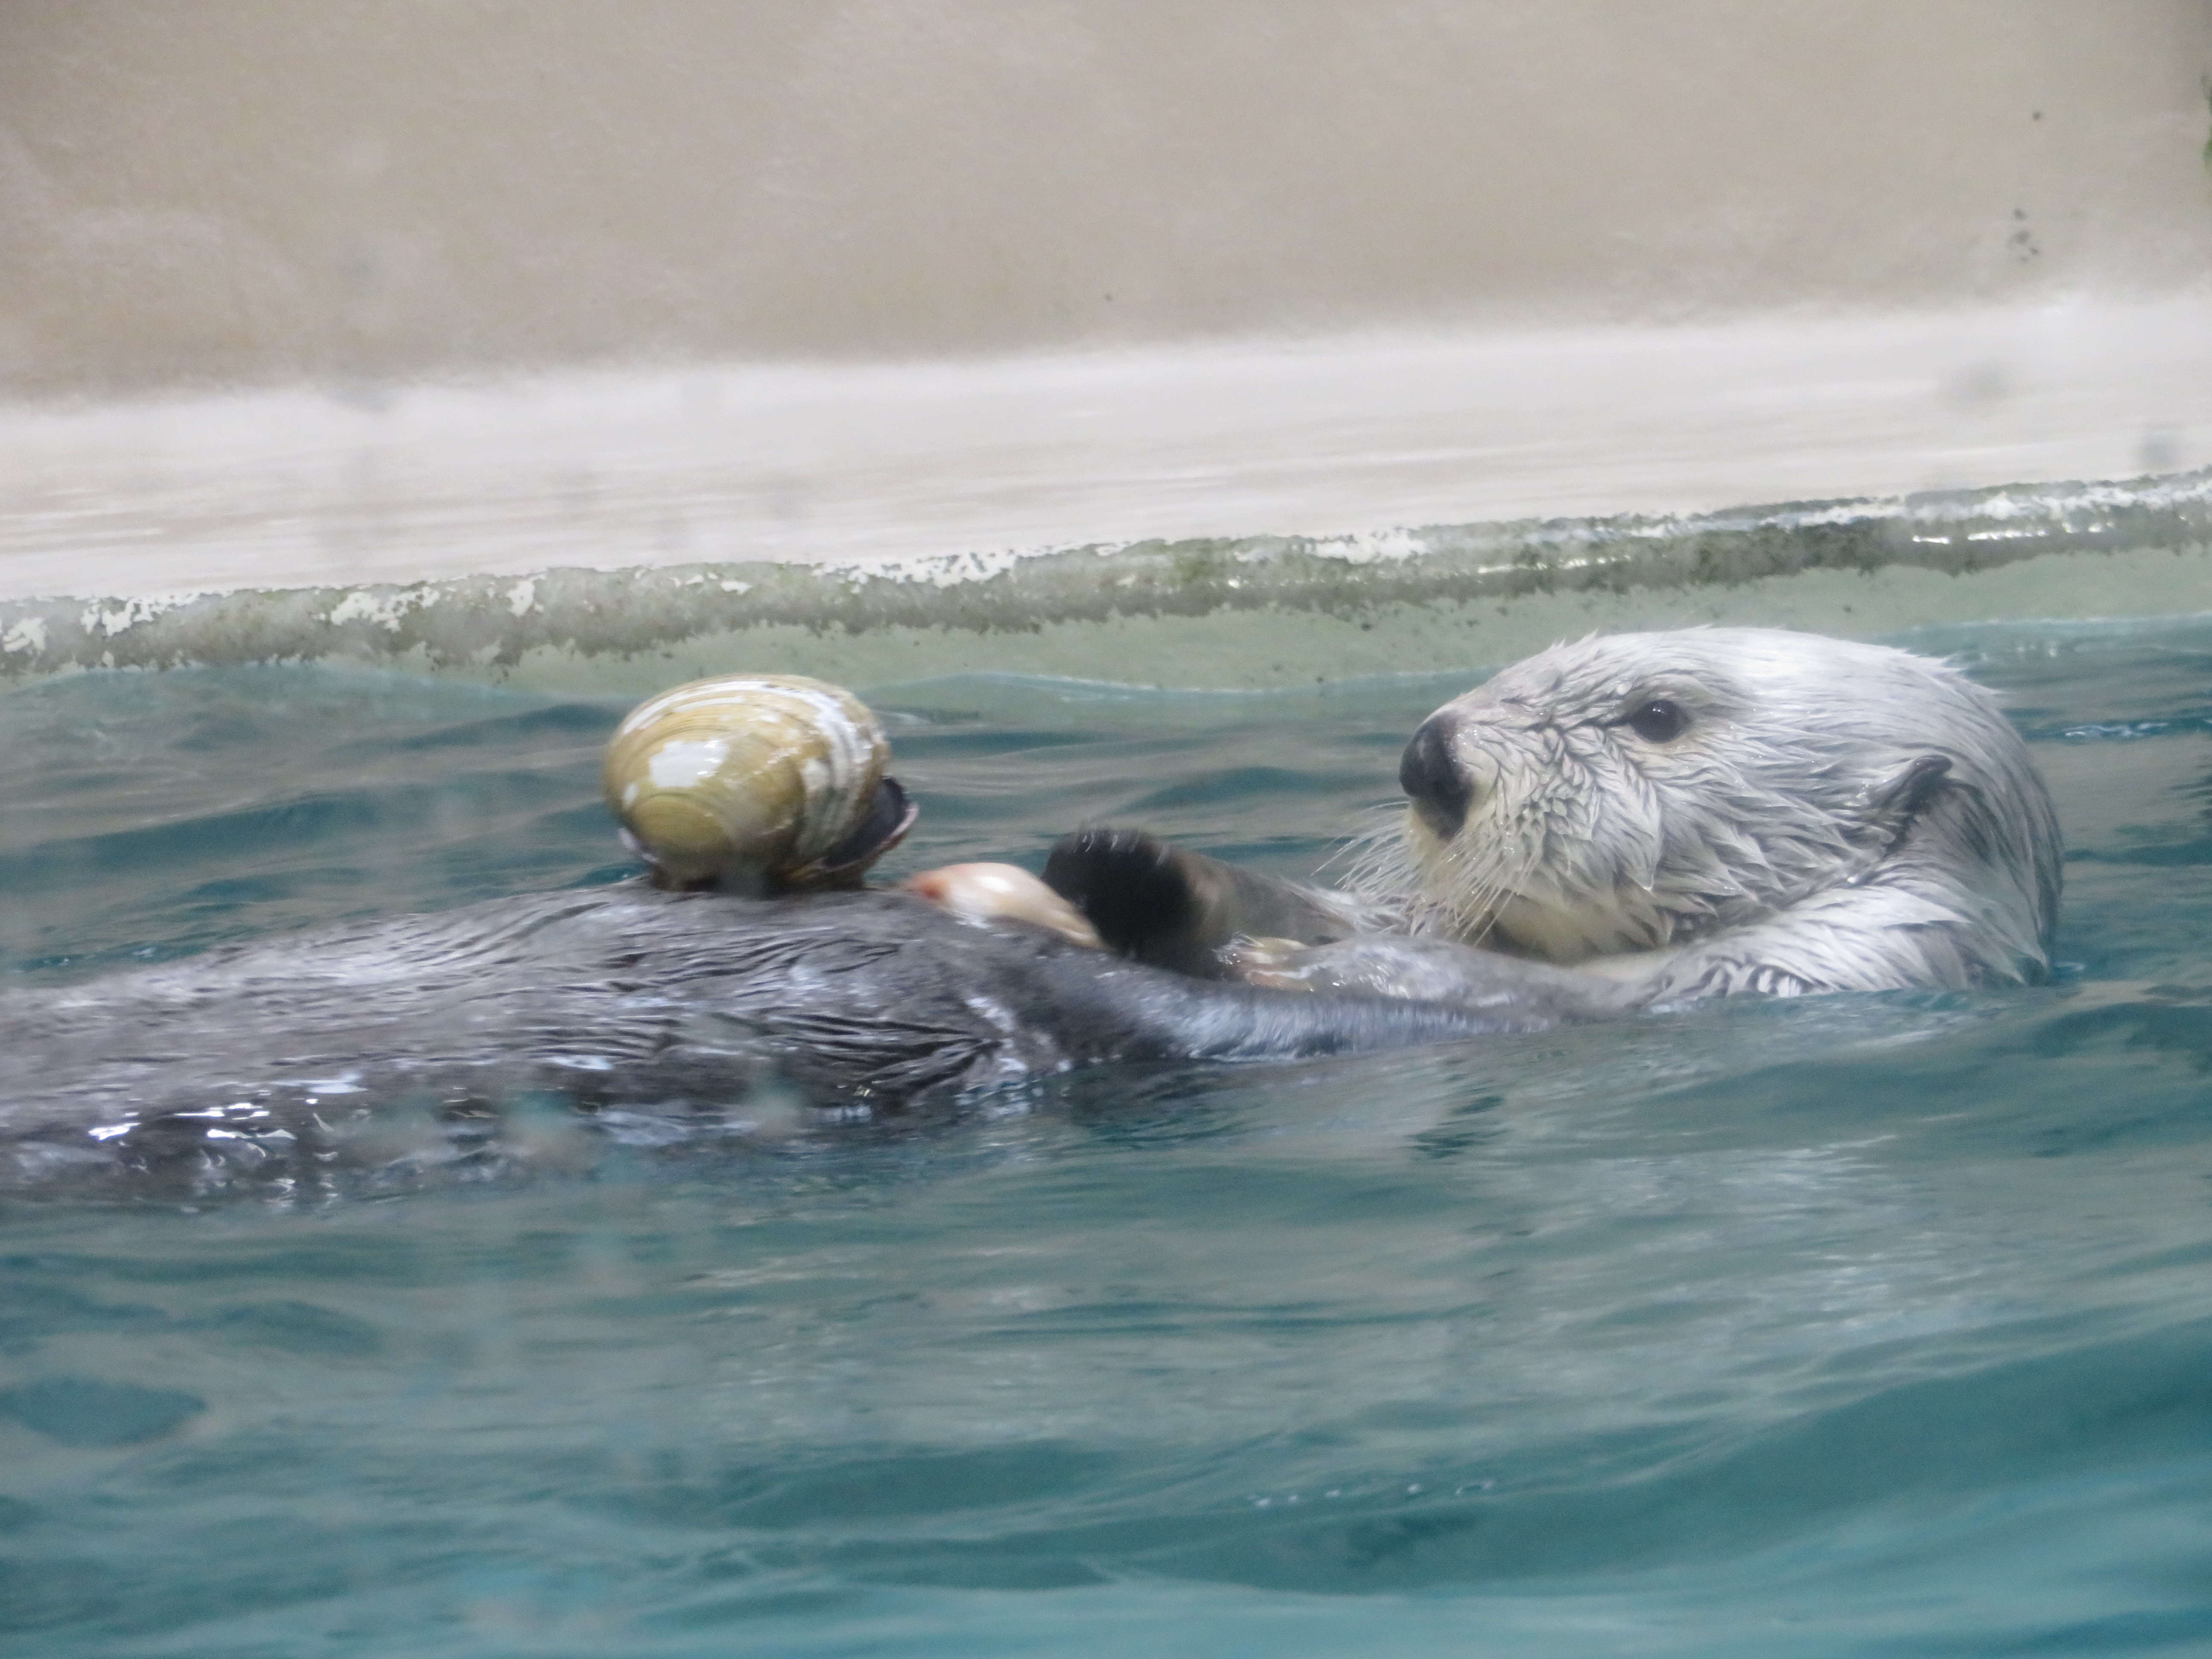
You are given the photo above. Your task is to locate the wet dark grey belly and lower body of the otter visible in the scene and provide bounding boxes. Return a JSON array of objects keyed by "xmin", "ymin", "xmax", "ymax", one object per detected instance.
[{"xmin": 0, "ymin": 885, "xmax": 1548, "ymax": 1185}]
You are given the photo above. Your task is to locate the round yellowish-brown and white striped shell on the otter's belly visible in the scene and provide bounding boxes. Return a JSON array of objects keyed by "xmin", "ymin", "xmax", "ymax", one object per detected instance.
[{"xmin": 602, "ymin": 675, "xmax": 914, "ymax": 894}]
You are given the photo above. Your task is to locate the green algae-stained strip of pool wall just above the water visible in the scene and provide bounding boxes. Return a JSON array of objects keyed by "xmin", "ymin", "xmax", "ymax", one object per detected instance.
[{"xmin": 0, "ymin": 473, "xmax": 2212, "ymax": 693}]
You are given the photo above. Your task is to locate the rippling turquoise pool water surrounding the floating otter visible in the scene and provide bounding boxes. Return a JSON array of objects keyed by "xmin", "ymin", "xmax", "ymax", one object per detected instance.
[{"xmin": 0, "ymin": 624, "xmax": 2212, "ymax": 1659}]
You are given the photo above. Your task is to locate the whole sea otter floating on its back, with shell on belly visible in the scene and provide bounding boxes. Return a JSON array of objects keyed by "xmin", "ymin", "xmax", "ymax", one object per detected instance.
[{"xmin": 0, "ymin": 628, "xmax": 2059, "ymax": 1175}]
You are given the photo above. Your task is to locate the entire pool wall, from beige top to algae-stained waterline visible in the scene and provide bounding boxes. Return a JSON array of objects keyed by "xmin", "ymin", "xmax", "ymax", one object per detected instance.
[{"xmin": 0, "ymin": 0, "xmax": 2212, "ymax": 690}]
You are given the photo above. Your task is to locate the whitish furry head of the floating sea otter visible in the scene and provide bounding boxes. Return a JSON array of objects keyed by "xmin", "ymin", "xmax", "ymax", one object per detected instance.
[{"xmin": 1367, "ymin": 628, "xmax": 2059, "ymax": 962}]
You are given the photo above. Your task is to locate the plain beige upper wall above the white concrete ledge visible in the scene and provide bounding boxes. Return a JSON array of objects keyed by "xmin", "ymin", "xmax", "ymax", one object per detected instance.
[{"xmin": 0, "ymin": 0, "xmax": 2212, "ymax": 392}]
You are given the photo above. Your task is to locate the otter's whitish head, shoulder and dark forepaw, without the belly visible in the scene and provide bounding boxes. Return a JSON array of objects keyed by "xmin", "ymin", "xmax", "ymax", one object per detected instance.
[{"xmin": 1046, "ymin": 628, "xmax": 2059, "ymax": 1015}]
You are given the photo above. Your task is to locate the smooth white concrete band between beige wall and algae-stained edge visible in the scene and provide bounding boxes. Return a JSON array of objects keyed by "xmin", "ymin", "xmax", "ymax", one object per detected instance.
[{"xmin": 0, "ymin": 299, "xmax": 2212, "ymax": 600}]
